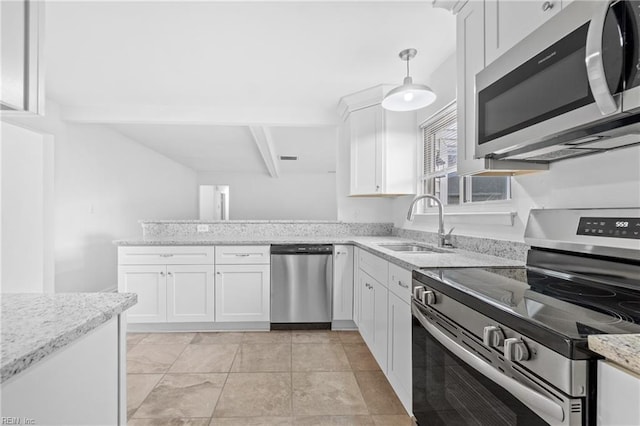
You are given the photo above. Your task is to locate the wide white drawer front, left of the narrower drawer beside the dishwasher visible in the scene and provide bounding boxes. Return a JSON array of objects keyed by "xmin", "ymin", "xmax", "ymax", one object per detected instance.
[{"xmin": 118, "ymin": 246, "xmax": 213, "ymax": 265}]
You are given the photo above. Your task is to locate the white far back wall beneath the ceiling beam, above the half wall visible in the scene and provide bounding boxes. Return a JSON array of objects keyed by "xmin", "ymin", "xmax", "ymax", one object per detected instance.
[{"xmin": 198, "ymin": 172, "xmax": 336, "ymax": 220}]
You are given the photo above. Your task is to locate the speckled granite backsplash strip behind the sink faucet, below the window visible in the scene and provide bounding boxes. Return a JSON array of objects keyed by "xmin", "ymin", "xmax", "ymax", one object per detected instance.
[{"xmin": 392, "ymin": 227, "xmax": 529, "ymax": 262}]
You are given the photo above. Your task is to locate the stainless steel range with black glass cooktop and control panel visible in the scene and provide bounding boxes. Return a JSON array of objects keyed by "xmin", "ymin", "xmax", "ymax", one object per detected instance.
[{"xmin": 412, "ymin": 208, "xmax": 640, "ymax": 426}]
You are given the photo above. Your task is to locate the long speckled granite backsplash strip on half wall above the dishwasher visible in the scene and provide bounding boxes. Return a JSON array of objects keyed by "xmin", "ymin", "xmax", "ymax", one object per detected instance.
[{"xmin": 141, "ymin": 220, "xmax": 393, "ymax": 240}]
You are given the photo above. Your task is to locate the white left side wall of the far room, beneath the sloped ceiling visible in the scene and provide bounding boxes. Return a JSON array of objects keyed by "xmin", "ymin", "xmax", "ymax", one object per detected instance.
[{"xmin": 3, "ymin": 100, "xmax": 197, "ymax": 292}]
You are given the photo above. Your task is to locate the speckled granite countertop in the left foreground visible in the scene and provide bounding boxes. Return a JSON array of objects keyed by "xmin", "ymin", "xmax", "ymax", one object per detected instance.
[{"xmin": 0, "ymin": 293, "xmax": 138, "ymax": 383}]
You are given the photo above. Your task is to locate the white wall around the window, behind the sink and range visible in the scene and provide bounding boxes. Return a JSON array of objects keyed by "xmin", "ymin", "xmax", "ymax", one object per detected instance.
[{"xmin": 393, "ymin": 53, "xmax": 640, "ymax": 241}]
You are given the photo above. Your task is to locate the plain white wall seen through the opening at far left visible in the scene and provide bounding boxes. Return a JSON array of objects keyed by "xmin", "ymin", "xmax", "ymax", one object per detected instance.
[{"xmin": 0, "ymin": 123, "xmax": 54, "ymax": 293}]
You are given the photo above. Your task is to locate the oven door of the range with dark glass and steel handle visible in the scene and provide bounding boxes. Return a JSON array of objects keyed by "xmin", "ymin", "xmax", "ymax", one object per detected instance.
[{"xmin": 412, "ymin": 302, "xmax": 571, "ymax": 426}]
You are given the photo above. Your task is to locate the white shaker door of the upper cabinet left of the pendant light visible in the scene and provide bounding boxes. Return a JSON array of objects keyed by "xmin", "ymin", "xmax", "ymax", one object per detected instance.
[{"xmin": 349, "ymin": 105, "xmax": 382, "ymax": 195}]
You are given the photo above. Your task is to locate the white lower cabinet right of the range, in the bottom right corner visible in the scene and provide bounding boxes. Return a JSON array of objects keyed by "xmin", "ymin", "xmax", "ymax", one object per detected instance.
[{"xmin": 597, "ymin": 360, "xmax": 640, "ymax": 426}]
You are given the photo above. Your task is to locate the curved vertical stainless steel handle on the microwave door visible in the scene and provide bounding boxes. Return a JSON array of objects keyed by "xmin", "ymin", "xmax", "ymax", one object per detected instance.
[{"xmin": 585, "ymin": 1, "xmax": 618, "ymax": 115}]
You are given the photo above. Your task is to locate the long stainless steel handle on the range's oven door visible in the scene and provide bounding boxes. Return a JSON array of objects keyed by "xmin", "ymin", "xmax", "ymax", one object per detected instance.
[{"xmin": 411, "ymin": 305, "xmax": 565, "ymax": 424}]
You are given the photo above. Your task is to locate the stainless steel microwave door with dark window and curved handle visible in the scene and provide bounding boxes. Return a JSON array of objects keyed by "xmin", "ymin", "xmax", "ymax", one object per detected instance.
[{"xmin": 475, "ymin": 1, "xmax": 633, "ymax": 158}]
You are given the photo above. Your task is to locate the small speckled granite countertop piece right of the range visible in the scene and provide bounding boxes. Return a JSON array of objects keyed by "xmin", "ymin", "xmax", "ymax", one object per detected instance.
[{"xmin": 588, "ymin": 334, "xmax": 640, "ymax": 374}]
